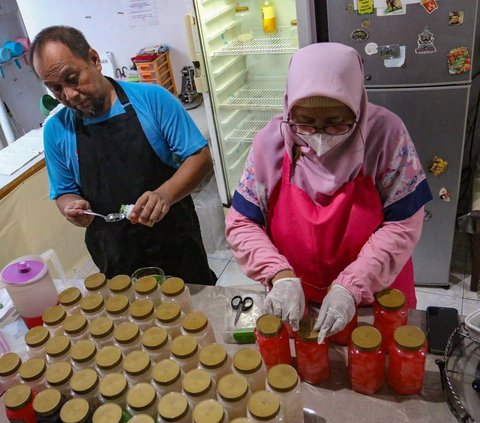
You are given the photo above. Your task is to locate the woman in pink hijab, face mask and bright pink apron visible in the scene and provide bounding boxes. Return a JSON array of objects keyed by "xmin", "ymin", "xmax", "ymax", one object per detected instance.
[{"xmin": 226, "ymin": 43, "xmax": 432, "ymax": 342}]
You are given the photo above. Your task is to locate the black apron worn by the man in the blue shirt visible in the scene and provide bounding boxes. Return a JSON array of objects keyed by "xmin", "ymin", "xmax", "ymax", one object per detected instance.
[{"xmin": 75, "ymin": 78, "xmax": 216, "ymax": 285}]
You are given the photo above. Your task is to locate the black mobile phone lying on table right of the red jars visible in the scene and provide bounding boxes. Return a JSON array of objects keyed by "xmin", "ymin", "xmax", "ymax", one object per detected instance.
[{"xmin": 427, "ymin": 306, "xmax": 458, "ymax": 355}]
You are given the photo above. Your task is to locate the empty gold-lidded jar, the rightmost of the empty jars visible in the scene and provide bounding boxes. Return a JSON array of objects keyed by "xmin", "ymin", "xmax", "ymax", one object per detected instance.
[{"xmin": 266, "ymin": 364, "xmax": 303, "ymax": 423}]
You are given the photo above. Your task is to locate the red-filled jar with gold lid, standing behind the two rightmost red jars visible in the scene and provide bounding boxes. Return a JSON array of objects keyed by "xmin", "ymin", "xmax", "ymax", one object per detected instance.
[{"xmin": 373, "ymin": 288, "xmax": 408, "ymax": 352}]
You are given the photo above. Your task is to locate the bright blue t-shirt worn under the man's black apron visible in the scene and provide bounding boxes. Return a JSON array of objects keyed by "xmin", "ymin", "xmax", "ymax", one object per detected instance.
[{"xmin": 43, "ymin": 81, "xmax": 208, "ymax": 199}]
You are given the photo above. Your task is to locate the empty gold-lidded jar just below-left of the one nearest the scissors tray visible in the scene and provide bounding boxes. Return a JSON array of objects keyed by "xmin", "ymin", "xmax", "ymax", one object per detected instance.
[{"xmin": 217, "ymin": 373, "xmax": 251, "ymax": 419}]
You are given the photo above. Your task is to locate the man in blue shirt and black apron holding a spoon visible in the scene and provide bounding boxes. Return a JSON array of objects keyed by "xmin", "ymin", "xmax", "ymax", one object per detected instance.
[{"xmin": 30, "ymin": 26, "xmax": 216, "ymax": 284}]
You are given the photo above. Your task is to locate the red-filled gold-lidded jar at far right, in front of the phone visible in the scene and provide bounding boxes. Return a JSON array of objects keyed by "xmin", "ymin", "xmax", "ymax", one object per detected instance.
[{"xmin": 388, "ymin": 325, "xmax": 427, "ymax": 395}]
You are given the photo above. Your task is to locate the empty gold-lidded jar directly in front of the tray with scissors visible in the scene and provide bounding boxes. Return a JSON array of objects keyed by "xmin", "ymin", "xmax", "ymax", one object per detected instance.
[{"xmin": 232, "ymin": 348, "xmax": 267, "ymax": 392}]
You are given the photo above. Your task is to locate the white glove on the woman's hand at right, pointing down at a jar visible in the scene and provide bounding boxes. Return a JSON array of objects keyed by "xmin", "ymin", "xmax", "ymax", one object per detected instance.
[{"xmin": 314, "ymin": 285, "xmax": 355, "ymax": 344}]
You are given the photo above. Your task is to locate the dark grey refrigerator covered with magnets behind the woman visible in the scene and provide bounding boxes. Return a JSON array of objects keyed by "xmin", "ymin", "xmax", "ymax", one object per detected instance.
[{"xmin": 316, "ymin": 0, "xmax": 480, "ymax": 286}]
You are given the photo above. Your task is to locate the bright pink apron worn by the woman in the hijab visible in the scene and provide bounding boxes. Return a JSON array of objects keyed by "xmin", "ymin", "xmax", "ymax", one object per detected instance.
[{"xmin": 267, "ymin": 154, "xmax": 416, "ymax": 308}]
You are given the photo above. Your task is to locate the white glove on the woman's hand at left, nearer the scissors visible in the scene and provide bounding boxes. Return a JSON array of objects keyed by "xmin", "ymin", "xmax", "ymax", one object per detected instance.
[{"xmin": 263, "ymin": 278, "xmax": 305, "ymax": 331}]
